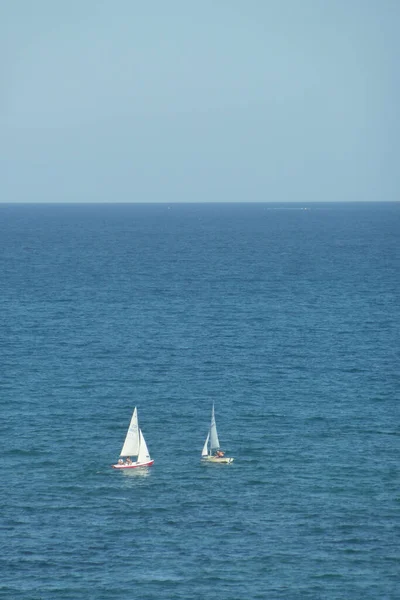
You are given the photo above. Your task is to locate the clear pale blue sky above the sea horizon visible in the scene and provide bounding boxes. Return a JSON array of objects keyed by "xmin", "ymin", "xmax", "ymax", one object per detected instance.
[{"xmin": 0, "ymin": 0, "xmax": 400, "ymax": 203}]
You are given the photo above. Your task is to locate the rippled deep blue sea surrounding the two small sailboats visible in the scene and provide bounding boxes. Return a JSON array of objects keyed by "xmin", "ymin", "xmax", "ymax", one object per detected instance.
[{"xmin": 0, "ymin": 203, "xmax": 400, "ymax": 600}]
